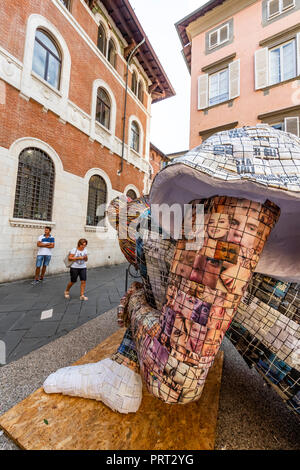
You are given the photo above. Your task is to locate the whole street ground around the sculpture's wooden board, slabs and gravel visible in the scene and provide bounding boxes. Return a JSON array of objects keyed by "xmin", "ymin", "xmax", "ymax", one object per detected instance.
[{"xmin": 0, "ymin": 264, "xmax": 300, "ymax": 450}]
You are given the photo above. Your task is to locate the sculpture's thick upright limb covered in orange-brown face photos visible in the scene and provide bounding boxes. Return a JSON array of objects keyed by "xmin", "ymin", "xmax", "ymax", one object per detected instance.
[{"xmin": 132, "ymin": 197, "xmax": 278, "ymax": 403}]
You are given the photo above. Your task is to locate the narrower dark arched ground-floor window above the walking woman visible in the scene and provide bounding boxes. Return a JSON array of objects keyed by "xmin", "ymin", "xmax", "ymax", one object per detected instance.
[{"xmin": 86, "ymin": 175, "xmax": 107, "ymax": 227}]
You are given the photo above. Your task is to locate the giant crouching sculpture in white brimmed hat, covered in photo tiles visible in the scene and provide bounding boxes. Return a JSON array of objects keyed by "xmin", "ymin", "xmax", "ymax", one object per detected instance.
[{"xmin": 44, "ymin": 126, "xmax": 300, "ymax": 413}]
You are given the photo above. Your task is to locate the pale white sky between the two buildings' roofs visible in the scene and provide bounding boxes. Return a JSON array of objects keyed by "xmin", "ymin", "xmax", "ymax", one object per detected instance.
[{"xmin": 129, "ymin": 0, "xmax": 207, "ymax": 153}]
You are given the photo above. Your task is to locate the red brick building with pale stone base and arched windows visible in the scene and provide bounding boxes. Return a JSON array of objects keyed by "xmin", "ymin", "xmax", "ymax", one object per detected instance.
[{"xmin": 0, "ymin": 0, "xmax": 174, "ymax": 282}]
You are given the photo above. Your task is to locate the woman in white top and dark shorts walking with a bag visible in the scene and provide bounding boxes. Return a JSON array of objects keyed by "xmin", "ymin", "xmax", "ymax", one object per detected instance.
[{"xmin": 64, "ymin": 238, "xmax": 88, "ymax": 300}]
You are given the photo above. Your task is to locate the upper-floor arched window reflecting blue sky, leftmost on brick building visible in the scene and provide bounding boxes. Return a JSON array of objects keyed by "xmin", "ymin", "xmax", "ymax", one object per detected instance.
[{"xmin": 32, "ymin": 29, "xmax": 61, "ymax": 89}]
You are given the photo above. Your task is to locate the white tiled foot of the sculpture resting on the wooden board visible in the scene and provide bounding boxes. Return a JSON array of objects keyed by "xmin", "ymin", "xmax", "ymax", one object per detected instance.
[{"xmin": 43, "ymin": 358, "xmax": 142, "ymax": 413}]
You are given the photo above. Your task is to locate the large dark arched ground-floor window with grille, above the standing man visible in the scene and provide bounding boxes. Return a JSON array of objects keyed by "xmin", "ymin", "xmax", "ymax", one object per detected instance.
[{"xmin": 14, "ymin": 147, "xmax": 55, "ymax": 221}]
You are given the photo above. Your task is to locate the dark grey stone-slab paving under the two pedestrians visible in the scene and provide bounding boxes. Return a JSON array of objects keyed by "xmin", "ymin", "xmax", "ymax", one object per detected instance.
[{"xmin": 0, "ymin": 264, "xmax": 138, "ymax": 366}]
